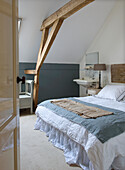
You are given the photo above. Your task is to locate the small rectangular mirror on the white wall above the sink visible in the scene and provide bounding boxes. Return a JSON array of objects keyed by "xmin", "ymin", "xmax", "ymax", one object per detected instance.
[{"xmin": 85, "ymin": 52, "xmax": 99, "ymax": 69}]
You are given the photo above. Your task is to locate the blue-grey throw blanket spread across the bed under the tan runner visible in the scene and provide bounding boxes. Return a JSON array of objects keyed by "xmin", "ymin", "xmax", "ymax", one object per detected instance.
[{"xmin": 39, "ymin": 98, "xmax": 125, "ymax": 143}]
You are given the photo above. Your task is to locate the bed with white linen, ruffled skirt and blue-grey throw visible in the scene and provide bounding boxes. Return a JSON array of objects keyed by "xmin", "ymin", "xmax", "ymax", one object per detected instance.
[{"xmin": 35, "ymin": 64, "xmax": 125, "ymax": 170}]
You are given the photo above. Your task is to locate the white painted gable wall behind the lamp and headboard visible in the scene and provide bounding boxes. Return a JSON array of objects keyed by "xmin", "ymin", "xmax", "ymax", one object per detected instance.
[{"xmin": 80, "ymin": 0, "xmax": 125, "ymax": 93}]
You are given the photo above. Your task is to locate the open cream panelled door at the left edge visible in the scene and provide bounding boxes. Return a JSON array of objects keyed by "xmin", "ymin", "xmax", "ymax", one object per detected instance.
[{"xmin": 0, "ymin": 0, "xmax": 19, "ymax": 170}]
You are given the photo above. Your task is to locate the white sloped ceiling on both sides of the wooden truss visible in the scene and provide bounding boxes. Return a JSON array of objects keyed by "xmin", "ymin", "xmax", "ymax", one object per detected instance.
[{"xmin": 19, "ymin": 0, "xmax": 115, "ymax": 63}]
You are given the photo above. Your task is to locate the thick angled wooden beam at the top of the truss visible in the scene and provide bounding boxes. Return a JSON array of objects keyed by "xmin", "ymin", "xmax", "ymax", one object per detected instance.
[{"xmin": 41, "ymin": 0, "xmax": 95, "ymax": 31}]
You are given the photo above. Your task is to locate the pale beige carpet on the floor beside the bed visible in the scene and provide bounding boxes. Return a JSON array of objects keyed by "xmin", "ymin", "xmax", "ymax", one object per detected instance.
[{"xmin": 20, "ymin": 111, "xmax": 81, "ymax": 170}]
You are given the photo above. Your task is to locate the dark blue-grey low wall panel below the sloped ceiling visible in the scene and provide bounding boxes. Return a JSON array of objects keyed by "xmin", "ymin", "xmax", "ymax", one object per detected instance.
[{"xmin": 19, "ymin": 63, "xmax": 79, "ymax": 103}]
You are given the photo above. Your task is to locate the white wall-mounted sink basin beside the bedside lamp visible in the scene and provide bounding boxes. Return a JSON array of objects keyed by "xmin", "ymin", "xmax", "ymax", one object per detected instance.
[{"xmin": 73, "ymin": 79, "xmax": 98, "ymax": 87}]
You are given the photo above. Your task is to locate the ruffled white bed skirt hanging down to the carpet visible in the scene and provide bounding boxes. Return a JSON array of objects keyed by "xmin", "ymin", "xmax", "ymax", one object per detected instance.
[{"xmin": 35, "ymin": 118, "xmax": 94, "ymax": 170}]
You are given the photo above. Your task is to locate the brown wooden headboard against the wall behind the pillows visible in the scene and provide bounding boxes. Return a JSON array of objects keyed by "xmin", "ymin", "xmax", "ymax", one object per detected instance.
[{"xmin": 111, "ymin": 64, "xmax": 125, "ymax": 83}]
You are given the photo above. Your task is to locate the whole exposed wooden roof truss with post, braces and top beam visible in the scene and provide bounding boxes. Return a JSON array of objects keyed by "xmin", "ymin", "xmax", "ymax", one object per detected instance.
[{"xmin": 25, "ymin": 0, "xmax": 95, "ymax": 108}]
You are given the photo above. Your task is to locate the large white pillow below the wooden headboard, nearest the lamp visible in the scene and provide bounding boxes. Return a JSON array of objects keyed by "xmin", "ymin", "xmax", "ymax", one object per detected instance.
[{"xmin": 96, "ymin": 85, "xmax": 125, "ymax": 101}]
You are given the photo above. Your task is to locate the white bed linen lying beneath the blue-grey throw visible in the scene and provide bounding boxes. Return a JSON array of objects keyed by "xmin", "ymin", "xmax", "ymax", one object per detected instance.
[{"xmin": 35, "ymin": 96, "xmax": 125, "ymax": 170}]
